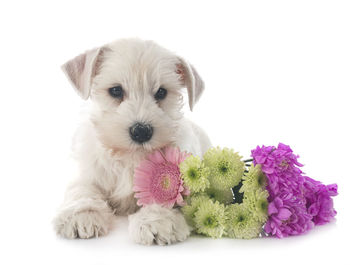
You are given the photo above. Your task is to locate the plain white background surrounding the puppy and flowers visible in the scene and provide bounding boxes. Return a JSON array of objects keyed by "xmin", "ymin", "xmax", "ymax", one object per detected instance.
[{"xmin": 0, "ymin": 0, "xmax": 350, "ymax": 265}]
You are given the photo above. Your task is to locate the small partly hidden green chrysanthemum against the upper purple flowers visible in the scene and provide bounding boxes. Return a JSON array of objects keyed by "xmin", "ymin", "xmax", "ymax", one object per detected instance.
[{"xmin": 240, "ymin": 164, "xmax": 267, "ymax": 193}]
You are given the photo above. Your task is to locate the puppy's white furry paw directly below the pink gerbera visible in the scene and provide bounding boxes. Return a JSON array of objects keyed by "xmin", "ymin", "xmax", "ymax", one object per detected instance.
[{"xmin": 129, "ymin": 205, "xmax": 190, "ymax": 245}]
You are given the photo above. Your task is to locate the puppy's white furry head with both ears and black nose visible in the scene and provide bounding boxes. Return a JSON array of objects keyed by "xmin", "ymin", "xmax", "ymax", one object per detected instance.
[{"xmin": 62, "ymin": 39, "xmax": 204, "ymax": 151}]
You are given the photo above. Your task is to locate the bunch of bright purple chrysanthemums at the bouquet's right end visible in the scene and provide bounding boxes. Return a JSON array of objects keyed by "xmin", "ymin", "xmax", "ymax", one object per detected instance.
[{"xmin": 252, "ymin": 143, "xmax": 337, "ymax": 238}]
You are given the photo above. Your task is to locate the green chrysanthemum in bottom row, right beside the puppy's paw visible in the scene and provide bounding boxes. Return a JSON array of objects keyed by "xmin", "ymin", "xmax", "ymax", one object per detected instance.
[{"xmin": 194, "ymin": 200, "xmax": 226, "ymax": 238}]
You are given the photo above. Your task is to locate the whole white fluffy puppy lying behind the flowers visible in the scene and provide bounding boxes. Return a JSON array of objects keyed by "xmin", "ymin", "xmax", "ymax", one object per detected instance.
[{"xmin": 54, "ymin": 39, "xmax": 210, "ymax": 245}]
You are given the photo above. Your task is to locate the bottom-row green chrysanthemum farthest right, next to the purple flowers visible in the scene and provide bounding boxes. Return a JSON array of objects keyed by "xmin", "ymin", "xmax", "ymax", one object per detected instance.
[{"xmin": 226, "ymin": 203, "xmax": 262, "ymax": 239}]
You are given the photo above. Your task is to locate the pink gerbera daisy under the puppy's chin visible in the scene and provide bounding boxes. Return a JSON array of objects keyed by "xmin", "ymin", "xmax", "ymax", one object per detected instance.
[{"xmin": 134, "ymin": 147, "xmax": 189, "ymax": 208}]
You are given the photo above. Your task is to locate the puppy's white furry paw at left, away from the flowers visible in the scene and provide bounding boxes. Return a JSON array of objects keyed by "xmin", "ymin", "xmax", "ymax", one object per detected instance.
[{"xmin": 54, "ymin": 207, "xmax": 111, "ymax": 238}]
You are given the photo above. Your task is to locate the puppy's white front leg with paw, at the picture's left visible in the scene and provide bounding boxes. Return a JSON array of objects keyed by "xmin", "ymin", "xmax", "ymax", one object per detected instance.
[{"xmin": 54, "ymin": 181, "xmax": 113, "ymax": 238}]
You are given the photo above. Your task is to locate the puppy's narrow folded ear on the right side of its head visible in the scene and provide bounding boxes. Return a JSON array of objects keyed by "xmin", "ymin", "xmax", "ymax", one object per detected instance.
[{"xmin": 176, "ymin": 57, "xmax": 204, "ymax": 111}]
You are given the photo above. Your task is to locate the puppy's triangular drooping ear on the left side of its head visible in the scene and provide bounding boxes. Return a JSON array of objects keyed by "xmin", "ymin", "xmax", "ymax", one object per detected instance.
[{"xmin": 62, "ymin": 48, "xmax": 102, "ymax": 100}]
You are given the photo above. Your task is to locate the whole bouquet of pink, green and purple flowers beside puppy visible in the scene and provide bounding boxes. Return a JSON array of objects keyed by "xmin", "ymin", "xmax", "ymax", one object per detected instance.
[{"xmin": 134, "ymin": 143, "xmax": 337, "ymax": 239}]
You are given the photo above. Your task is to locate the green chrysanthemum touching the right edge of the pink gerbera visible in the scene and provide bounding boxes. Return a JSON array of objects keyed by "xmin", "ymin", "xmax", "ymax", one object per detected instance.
[{"xmin": 180, "ymin": 156, "xmax": 209, "ymax": 192}]
